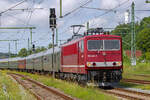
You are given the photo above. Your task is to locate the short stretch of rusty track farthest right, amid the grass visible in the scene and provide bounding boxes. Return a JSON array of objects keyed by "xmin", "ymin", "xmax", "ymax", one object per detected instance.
[{"xmin": 121, "ymin": 79, "xmax": 150, "ymax": 84}]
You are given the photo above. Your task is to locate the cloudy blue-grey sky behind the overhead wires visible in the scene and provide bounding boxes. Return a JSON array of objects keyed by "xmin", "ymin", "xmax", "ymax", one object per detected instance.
[{"xmin": 0, "ymin": 0, "xmax": 150, "ymax": 53}]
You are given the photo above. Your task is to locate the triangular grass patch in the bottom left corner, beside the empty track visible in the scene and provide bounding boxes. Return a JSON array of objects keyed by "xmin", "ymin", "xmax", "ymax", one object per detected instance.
[{"xmin": 0, "ymin": 71, "xmax": 36, "ymax": 100}]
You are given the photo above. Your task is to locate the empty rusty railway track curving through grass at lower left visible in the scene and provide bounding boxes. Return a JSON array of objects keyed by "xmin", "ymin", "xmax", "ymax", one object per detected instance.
[{"xmin": 8, "ymin": 73, "xmax": 77, "ymax": 100}]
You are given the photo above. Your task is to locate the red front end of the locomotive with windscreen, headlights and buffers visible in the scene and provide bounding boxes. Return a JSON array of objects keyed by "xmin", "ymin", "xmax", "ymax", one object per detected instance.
[{"xmin": 85, "ymin": 35, "xmax": 123, "ymax": 85}]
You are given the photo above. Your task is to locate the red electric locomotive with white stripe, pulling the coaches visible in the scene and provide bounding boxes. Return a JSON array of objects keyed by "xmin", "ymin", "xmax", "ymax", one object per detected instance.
[{"xmin": 61, "ymin": 27, "xmax": 123, "ymax": 86}]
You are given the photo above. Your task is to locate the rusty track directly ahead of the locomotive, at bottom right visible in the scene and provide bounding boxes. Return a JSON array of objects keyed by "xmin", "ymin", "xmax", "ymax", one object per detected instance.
[{"xmin": 103, "ymin": 88, "xmax": 150, "ymax": 100}]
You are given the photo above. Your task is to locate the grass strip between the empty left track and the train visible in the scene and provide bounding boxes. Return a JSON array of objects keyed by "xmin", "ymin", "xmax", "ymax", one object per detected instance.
[{"xmin": 5, "ymin": 69, "xmax": 116, "ymax": 100}]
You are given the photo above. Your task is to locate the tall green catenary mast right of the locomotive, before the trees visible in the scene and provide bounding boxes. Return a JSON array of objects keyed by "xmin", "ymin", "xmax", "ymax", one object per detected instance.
[{"xmin": 131, "ymin": 2, "xmax": 136, "ymax": 66}]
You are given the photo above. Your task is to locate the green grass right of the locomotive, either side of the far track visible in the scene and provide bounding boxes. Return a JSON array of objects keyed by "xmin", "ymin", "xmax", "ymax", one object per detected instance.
[{"xmin": 120, "ymin": 63, "xmax": 150, "ymax": 90}]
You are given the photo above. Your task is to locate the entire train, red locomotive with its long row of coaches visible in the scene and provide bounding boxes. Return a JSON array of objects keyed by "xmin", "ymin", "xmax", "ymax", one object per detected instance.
[{"xmin": 0, "ymin": 28, "xmax": 123, "ymax": 86}]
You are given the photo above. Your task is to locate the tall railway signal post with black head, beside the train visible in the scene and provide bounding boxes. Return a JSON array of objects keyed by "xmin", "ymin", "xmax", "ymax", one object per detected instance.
[{"xmin": 49, "ymin": 8, "xmax": 56, "ymax": 77}]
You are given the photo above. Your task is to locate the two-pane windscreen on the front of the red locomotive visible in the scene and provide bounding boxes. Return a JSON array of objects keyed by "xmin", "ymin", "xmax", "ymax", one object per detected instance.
[{"xmin": 88, "ymin": 40, "xmax": 120, "ymax": 51}]
